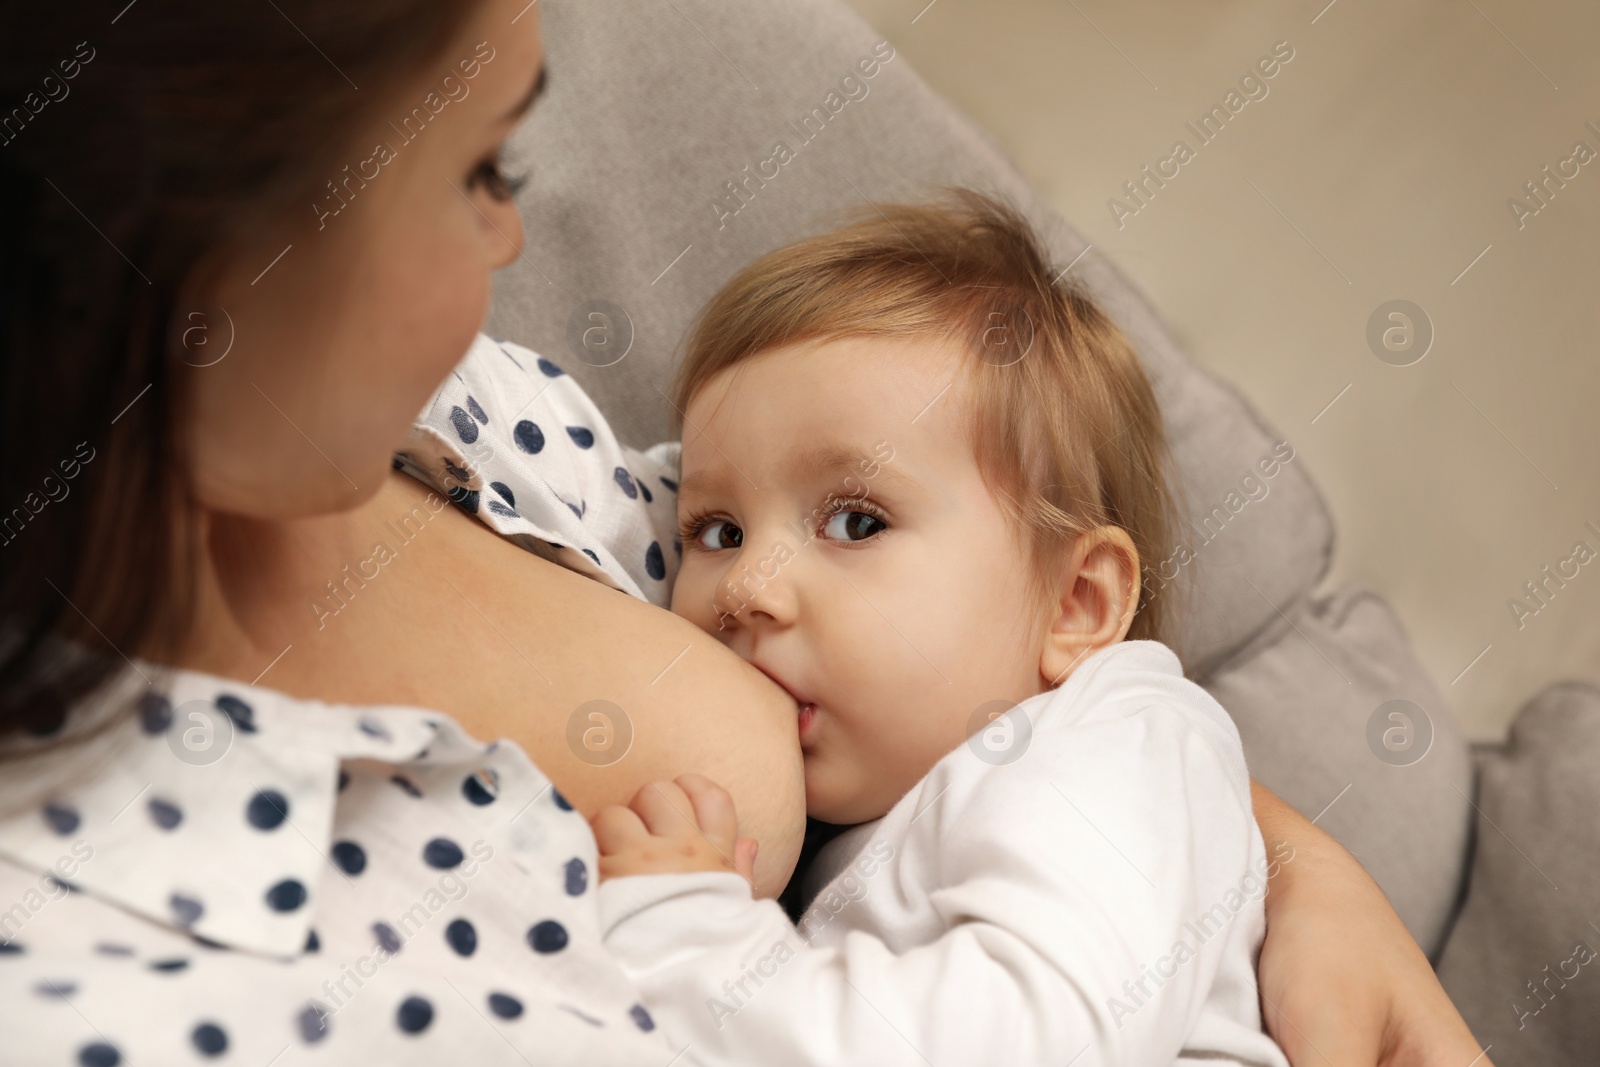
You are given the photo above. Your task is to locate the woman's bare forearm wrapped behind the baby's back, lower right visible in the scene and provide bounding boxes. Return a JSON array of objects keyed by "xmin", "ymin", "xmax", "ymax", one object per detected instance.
[{"xmin": 1251, "ymin": 782, "xmax": 1490, "ymax": 1067}]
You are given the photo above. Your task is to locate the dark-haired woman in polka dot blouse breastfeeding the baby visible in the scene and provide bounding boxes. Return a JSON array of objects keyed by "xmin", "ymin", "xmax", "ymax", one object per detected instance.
[{"xmin": 0, "ymin": 0, "xmax": 1483, "ymax": 1064}]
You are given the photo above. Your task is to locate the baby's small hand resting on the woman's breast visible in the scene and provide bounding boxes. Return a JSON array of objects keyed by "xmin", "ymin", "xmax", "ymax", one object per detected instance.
[{"xmin": 589, "ymin": 774, "xmax": 757, "ymax": 885}]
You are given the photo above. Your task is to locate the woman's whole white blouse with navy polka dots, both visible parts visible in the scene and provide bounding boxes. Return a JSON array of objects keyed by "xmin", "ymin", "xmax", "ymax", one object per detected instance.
[{"xmin": 0, "ymin": 338, "xmax": 677, "ymax": 1067}]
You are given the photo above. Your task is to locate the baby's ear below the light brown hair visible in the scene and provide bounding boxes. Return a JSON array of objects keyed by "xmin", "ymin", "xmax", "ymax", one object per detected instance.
[{"xmin": 1038, "ymin": 526, "xmax": 1139, "ymax": 688}]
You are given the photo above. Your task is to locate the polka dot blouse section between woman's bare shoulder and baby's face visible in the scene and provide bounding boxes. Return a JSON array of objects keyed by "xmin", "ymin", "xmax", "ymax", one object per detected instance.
[{"xmin": 395, "ymin": 336, "xmax": 680, "ymax": 606}]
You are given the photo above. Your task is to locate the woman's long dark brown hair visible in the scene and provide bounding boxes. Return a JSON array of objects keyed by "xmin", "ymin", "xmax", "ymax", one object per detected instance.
[{"xmin": 0, "ymin": 0, "xmax": 477, "ymax": 749}]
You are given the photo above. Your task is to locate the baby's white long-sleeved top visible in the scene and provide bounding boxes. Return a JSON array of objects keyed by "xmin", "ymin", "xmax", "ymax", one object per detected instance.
[{"xmin": 600, "ymin": 641, "xmax": 1293, "ymax": 1067}]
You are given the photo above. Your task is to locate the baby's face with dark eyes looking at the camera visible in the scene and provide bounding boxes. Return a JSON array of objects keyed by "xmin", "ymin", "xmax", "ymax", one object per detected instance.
[{"xmin": 672, "ymin": 338, "xmax": 1051, "ymax": 824}]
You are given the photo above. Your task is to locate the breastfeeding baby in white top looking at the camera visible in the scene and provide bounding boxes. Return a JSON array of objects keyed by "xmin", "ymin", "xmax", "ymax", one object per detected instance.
[{"xmin": 594, "ymin": 192, "xmax": 1285, "ymax": 1067}]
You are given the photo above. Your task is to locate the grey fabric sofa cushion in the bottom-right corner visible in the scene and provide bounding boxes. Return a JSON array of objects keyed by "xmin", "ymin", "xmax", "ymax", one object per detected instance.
[{"xmin": 1438, "ymin": 681, "xmax": 1600, "ymax": 1067}]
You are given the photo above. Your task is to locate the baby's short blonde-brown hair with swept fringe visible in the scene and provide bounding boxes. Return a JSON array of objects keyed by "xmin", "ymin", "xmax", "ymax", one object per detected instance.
[{"xmin": 674, "ymin": 189, "xmax": 1173, "ymax": 640}]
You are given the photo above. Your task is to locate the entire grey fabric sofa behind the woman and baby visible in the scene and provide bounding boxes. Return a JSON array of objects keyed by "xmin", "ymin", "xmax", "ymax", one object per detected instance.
[{"xmin": 490, "ymin": 0, "xmax": 1600, "ymax": 1067}]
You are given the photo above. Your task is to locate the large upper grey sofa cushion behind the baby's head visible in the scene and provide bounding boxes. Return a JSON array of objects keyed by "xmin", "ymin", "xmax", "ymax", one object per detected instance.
[{"xmin": 490, "ymin": 0, "xmax": 1333, "ymax": 675}]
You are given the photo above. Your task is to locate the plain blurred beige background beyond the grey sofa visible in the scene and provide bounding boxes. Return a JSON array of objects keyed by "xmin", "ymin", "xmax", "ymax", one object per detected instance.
[{"xmin": 853, "ymin": 0, "xmax": 1600, "ymax": 739}]
